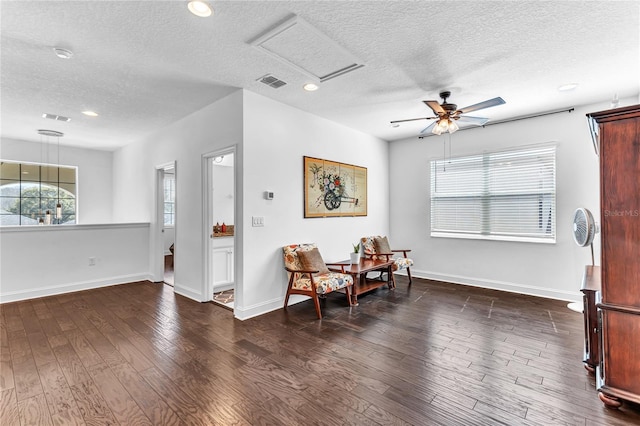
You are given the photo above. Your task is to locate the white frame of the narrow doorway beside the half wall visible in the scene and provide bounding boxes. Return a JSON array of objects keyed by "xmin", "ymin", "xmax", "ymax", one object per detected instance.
[{"xmin": 150, "ymin": 160, "xmax": 178, "ymax": 291}]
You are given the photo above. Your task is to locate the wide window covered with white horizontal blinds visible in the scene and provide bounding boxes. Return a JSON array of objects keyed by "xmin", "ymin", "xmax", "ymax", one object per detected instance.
[{"xmin": 431, "ymin": 146, "xmax": 556, "ymax": 243}]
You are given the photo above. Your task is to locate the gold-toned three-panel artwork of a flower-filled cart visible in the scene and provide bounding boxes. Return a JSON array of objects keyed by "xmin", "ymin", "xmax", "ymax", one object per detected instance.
[{"xmin": 303, "ymin": 156, "xmax": 367, "ymax": 218}]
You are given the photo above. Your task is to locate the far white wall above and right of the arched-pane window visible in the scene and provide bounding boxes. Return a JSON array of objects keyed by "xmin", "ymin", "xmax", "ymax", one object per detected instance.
[{"xmin": 0, "ymin": 138, "xmax": 113, "ymax": 224}]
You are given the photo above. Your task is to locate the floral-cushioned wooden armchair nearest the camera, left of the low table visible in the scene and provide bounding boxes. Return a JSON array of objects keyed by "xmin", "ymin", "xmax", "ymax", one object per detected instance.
[{"xmin": 282, "ymin": 244, "xmax": 353, "ymax": 319}]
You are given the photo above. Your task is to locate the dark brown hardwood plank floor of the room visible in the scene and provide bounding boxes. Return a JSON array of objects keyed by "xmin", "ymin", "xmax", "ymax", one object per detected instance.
[{"xmin": 0, "ymin": 277, "xmax": 640, "ymax": 426}]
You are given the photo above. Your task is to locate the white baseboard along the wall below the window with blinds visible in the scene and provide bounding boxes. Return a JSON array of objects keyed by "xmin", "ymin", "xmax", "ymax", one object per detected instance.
[{"xmin": 398, "ymin": 268, "xmax": 582, "ymax": 302}]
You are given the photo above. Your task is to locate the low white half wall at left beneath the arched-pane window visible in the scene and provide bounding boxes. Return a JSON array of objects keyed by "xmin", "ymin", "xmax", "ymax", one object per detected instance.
[{"xmin": 0, "ymin": 224, "xmax": 149, "ymax": 303}]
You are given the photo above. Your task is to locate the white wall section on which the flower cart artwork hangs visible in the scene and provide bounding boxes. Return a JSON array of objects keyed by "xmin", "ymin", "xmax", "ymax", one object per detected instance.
[{"xmin": 241, "ymin": 91, "xmax": 389, "ymax": 318}]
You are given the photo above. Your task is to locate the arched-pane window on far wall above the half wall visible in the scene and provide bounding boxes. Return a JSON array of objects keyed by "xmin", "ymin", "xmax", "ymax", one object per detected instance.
[{"xmin": 0, "ymin": 160, "xmax": 77, "ymax": 226}]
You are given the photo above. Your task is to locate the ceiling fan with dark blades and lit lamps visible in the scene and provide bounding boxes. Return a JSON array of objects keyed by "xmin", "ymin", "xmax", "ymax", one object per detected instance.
[{"xmin": 391, "ymin": 91, "xmax": 505, "ymax": 135}]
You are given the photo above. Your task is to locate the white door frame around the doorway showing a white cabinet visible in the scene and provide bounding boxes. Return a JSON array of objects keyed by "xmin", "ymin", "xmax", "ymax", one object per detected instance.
[{"xmin": 201, "ymin": 145, "xmax": 238, "ymax": 302}]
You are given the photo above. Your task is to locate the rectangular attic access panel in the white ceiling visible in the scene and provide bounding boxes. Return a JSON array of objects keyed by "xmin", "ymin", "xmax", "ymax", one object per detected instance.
[{"xmin": 251, "ymin": 15, "xmax": 364, "ymax": 82}]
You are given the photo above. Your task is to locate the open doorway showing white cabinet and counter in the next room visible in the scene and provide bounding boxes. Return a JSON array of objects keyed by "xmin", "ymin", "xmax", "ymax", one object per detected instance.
[{"xmin": 205, "ymin": 148, "xmax": 236, "ymax": 310}]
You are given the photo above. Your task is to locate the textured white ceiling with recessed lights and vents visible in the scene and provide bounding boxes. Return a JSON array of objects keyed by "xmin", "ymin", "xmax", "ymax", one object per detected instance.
[{"xmin": 0, "ymin": 0, "xmax": 640, "ymax": 149}]
